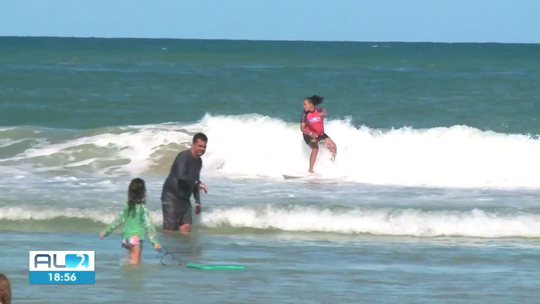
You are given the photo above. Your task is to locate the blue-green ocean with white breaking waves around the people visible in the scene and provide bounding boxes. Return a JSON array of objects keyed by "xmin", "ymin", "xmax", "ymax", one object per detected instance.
[{"xmin": 0, "ymin": 37, "xmax": 540, "ymax": 303}]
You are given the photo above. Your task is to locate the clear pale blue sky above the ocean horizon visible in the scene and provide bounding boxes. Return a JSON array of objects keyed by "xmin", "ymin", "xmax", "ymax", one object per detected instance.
[{"xmin": 0, "ymin": 0, "xmax": 540, "ymax": 43}]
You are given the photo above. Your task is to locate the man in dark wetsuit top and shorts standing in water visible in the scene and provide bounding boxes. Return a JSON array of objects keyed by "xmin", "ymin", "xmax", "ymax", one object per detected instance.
[{"xmin": 161, "ymin": 133, "xmax": 208, "ymax": 232}]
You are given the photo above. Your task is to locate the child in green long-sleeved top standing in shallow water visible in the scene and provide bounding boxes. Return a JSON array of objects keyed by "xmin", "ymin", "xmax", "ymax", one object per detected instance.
[{"xmin": 99, "ymin": 178, "xmax": 161, "ymax": 264}]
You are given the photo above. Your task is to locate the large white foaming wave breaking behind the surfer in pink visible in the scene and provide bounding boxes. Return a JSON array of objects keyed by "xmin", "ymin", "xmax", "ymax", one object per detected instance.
[{"xmin": 0, "ymin": 114, "xmax": 540, "ymax": 188}]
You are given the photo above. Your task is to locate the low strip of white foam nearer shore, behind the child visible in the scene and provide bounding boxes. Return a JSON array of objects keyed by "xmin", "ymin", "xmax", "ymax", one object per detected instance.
[{"xmin": 0, "ymin": 205, "xmax": 540, "ymax": 238}]
